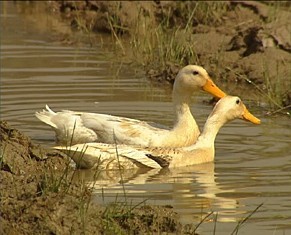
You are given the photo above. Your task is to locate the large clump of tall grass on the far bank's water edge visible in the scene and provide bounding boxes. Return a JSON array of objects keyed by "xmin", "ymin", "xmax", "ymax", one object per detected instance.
[{"xmin": 107, "ymin": 2, "xmax": 228, "ymax": 70}]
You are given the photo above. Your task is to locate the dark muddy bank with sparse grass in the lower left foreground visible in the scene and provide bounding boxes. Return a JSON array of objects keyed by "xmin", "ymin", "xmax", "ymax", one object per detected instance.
[{"xmin": 0, "ymin": 121, "xmax": 196, "ymax": 234}]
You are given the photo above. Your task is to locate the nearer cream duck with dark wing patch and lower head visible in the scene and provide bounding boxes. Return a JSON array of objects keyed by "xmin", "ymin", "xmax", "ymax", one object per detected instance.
[{"xmin": 54, "ymin": 96, "xmax": 261, "ymax": 170}]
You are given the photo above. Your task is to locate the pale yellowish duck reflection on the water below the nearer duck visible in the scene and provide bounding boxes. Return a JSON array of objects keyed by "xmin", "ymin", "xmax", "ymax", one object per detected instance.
[{"xmin": 75, "ymin": 162, "xmax": 244, "ymax": 223}]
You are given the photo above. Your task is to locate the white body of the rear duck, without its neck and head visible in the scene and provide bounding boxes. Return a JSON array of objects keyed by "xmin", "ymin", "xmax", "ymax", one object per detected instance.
[{"xmin": 38, "ymin": 106, "xmax": 199, "ymax": 147}]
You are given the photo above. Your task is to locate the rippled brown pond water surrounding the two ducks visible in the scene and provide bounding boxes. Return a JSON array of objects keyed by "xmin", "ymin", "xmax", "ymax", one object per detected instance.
[{"xmin": 1, "ymin": 2, "xmax": 291, "ymax": 235}]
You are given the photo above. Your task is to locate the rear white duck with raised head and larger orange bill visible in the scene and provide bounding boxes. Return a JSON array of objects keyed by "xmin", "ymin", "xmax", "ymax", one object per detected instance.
[{"xmin": 35, "ymin": 65, "xmax": 226, "ymax": 147}]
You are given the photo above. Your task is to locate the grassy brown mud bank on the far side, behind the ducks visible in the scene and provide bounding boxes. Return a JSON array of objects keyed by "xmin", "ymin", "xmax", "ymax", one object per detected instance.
[{"xmin": 9, "ymin": 0, "xmax": 291, "ymax": 111}]
